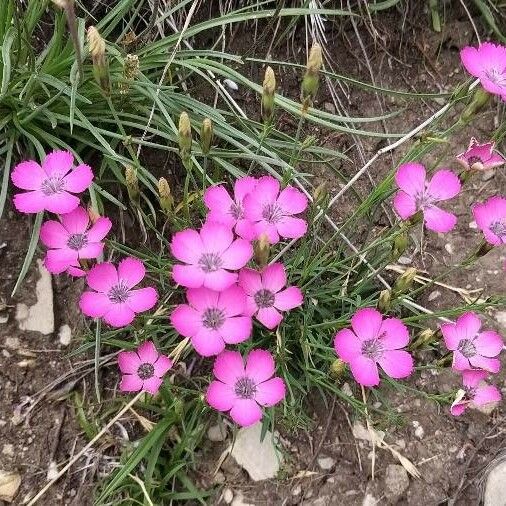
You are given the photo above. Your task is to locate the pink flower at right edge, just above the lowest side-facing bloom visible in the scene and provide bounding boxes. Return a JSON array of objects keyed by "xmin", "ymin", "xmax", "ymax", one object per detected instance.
[{"xmin": 441, "ymin": 312, "xmax": 503, "ymax": 373}]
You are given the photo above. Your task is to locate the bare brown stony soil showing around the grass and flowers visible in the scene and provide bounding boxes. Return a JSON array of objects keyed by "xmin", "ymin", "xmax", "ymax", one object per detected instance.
[{"xmin": 0, "ymin": 3, "xmax": 506, "ymax": 506}]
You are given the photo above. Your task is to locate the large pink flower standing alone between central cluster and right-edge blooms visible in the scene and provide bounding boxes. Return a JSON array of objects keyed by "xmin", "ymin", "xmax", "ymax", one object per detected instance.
[{"xmin": 334, "ymin": 308, "xmax": 413, "ymax": 387}]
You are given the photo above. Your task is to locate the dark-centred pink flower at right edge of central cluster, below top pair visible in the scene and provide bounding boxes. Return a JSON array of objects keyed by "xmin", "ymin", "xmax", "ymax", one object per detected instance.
[{"xmin": 239, "ymin": 263, "xmax": 303, "ymax": 329}]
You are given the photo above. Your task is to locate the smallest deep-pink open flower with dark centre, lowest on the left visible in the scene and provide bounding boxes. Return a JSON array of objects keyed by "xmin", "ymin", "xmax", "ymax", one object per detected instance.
[{"xmin": 118, "ymin": 341, "xmax": 172, "ymax": 395}]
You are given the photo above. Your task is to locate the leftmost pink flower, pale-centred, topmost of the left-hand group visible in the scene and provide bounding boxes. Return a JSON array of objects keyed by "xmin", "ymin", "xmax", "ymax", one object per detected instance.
[{"xmin": 11, "ymin": 151, "xmax": 93, "ymax": 214}]
